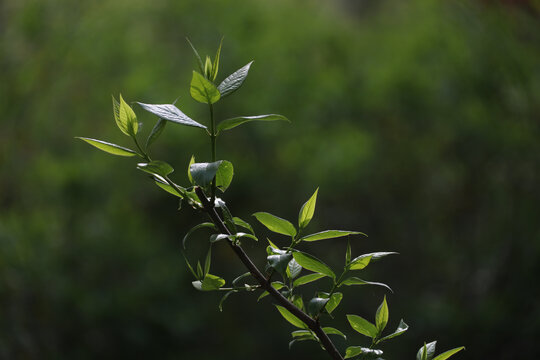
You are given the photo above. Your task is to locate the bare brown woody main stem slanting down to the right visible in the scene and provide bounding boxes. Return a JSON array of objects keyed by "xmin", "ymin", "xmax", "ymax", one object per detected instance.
[{"xmin": 195, "ymin": 187, "xmax": 343, "ymax": 360}]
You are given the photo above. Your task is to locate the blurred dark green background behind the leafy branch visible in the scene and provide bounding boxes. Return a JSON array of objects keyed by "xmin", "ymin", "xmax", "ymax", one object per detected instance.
[{"xmin": 0, "ymin": 0, "xmax": 540, "ymax": 360}]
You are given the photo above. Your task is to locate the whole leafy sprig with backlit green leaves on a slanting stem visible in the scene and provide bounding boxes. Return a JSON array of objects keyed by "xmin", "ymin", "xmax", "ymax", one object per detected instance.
[{"xmin": 79, "ymin": 39, "xmax": 463, "ymax": 360}]
